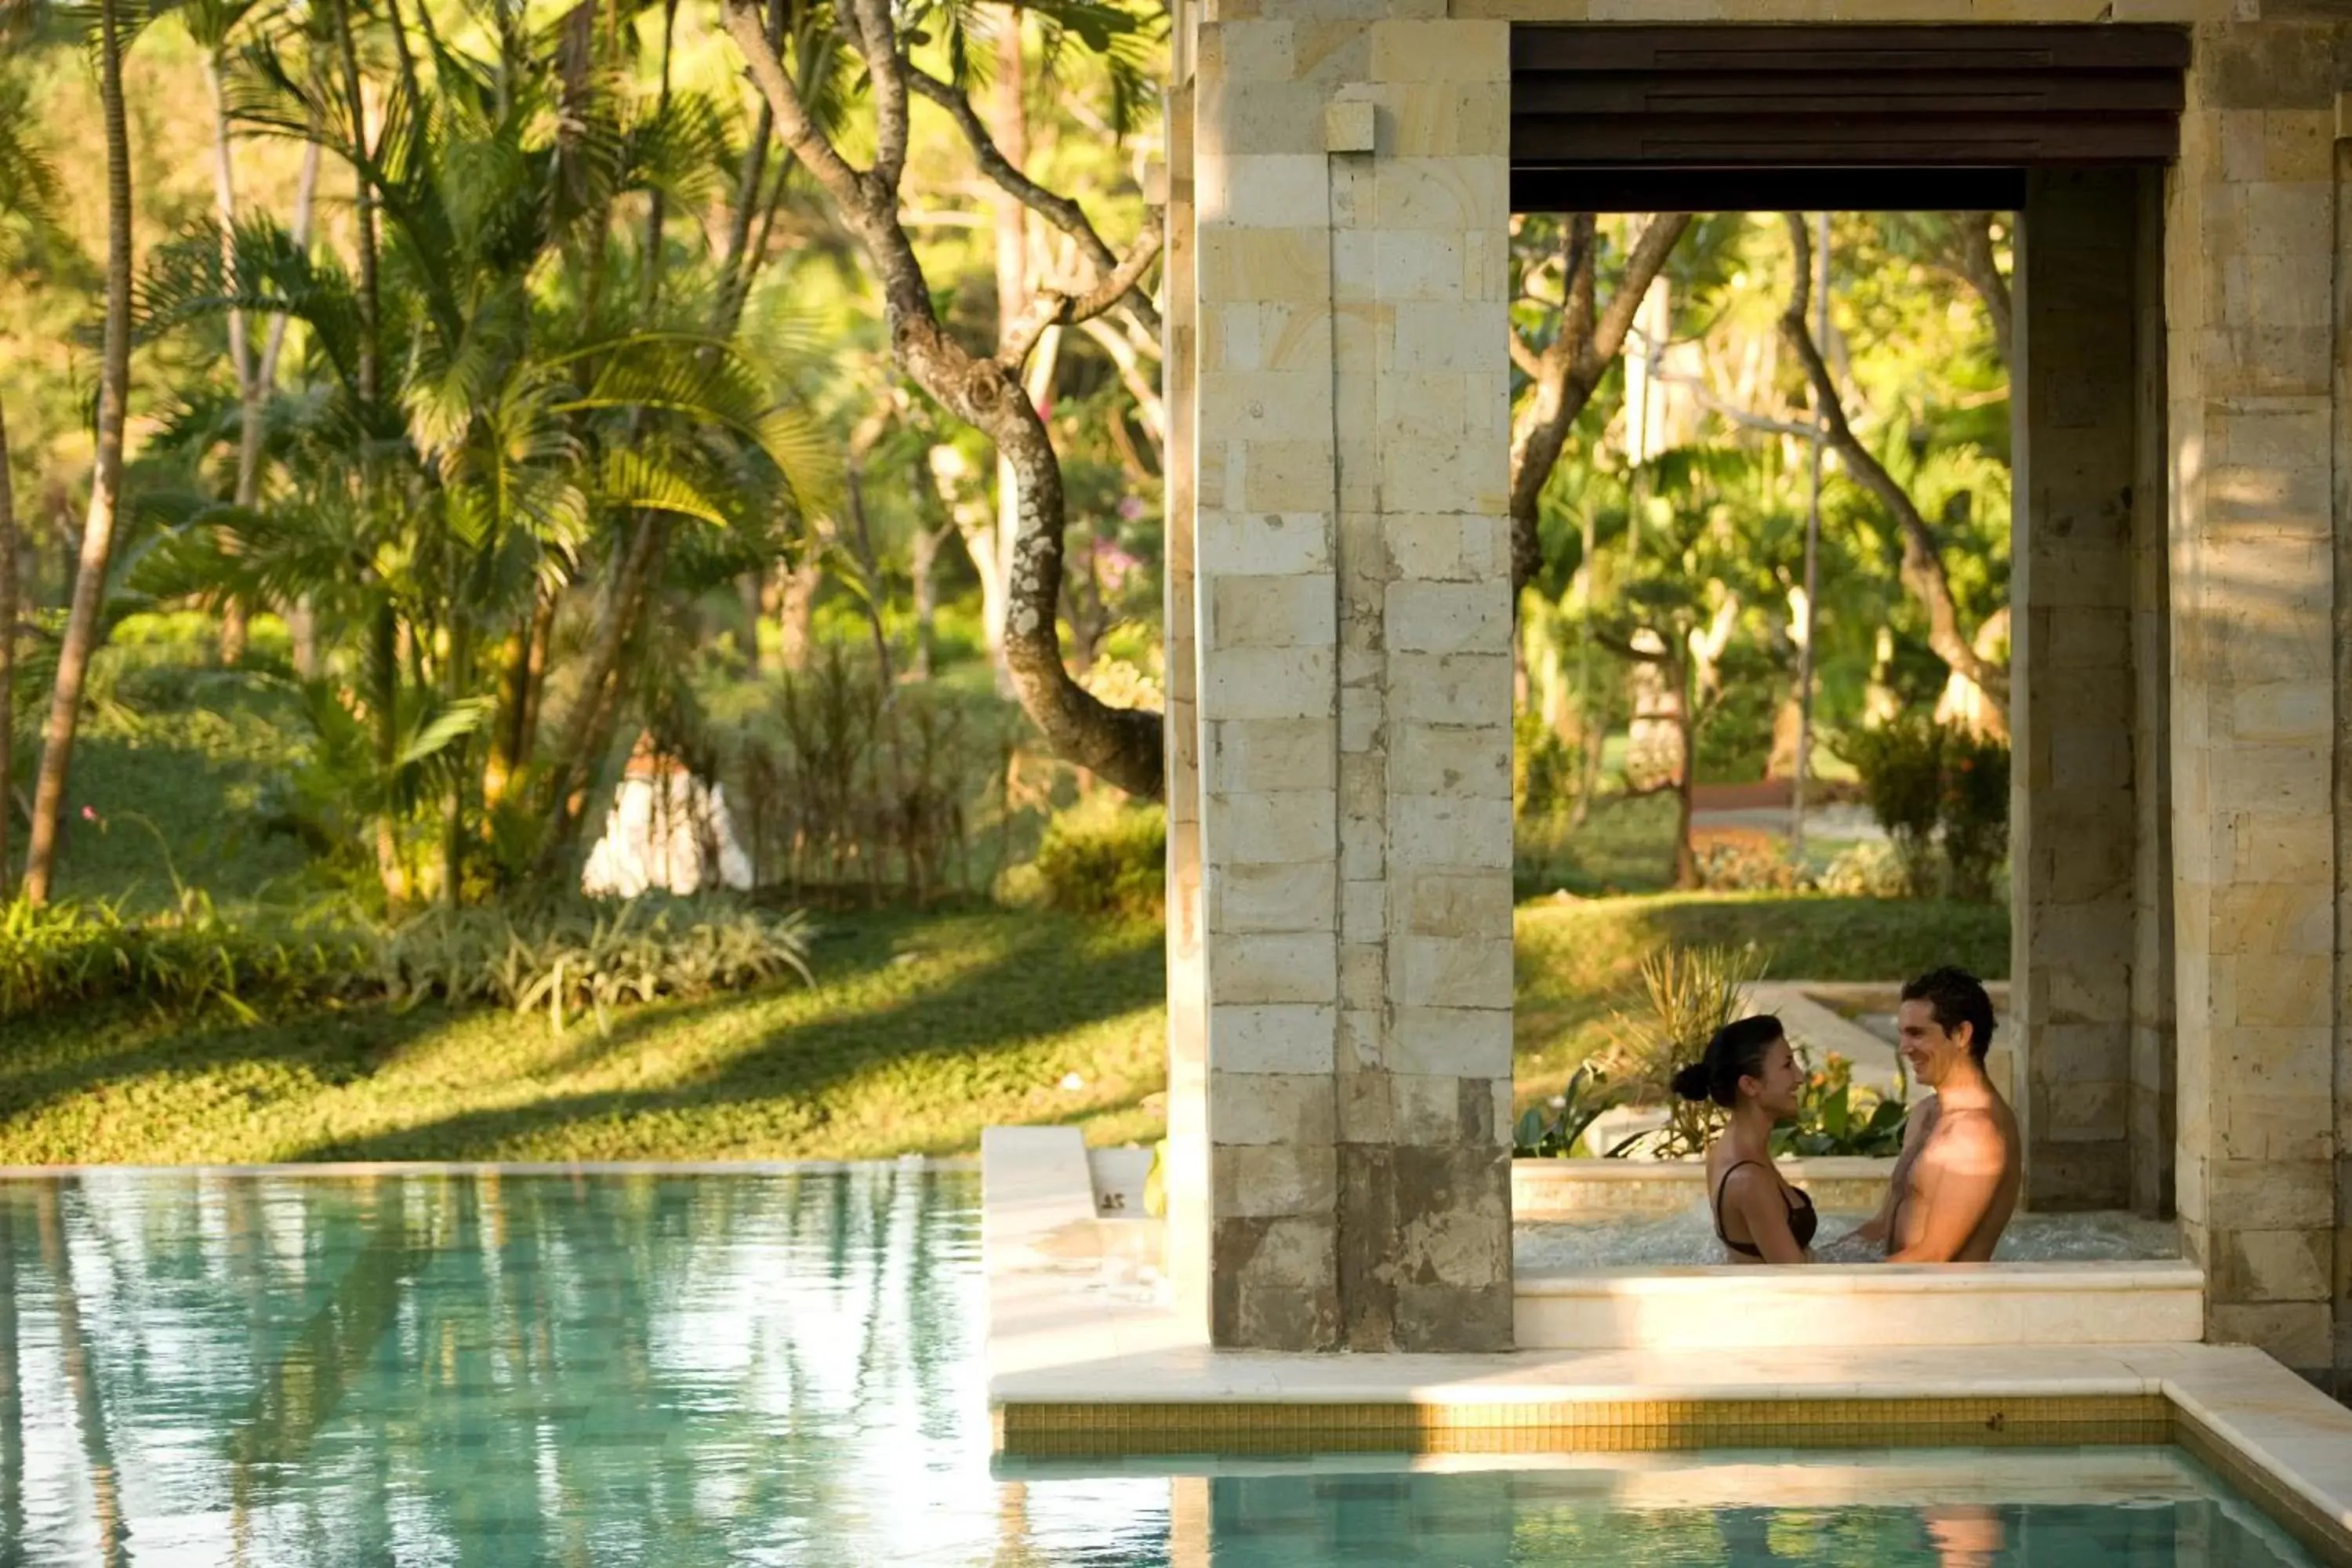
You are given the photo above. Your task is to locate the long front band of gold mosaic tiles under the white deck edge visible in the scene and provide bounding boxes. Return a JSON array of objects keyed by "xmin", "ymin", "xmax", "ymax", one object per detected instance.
[{"xmin": 995, "ymin": 1394, "xmax": 2173, "ymax": 1457}]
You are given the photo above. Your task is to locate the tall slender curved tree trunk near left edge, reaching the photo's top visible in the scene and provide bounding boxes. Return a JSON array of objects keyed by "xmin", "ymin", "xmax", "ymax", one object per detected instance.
[{"xmin": 24, "ymin": 0, "xmax": 132, "ymax": 905}]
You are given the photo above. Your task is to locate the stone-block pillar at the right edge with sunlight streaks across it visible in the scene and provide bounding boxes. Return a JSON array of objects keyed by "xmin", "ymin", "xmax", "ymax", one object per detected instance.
[{"xmin": 2166, "ymin": 5, "xmax": 2352, "ymax": 1377}]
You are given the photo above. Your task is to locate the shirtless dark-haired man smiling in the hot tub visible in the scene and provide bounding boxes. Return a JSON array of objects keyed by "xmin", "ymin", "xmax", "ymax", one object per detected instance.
[{"xmin": 1853, "ymin": 968, "xmax": 2023, "ymax": 1262}]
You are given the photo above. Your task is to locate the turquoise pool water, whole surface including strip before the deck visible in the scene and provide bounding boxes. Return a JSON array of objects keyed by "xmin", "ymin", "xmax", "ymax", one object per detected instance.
[{"xmin": 0, "ymin": 1168, "xmax": 2307, "ymax": 1568}]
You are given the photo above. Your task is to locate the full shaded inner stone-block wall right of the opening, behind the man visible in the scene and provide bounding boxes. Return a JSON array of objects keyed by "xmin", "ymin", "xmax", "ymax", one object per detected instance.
[{"xmin": 2009, "ymin": 169, "xmax": 2173, "ymax": 1213}]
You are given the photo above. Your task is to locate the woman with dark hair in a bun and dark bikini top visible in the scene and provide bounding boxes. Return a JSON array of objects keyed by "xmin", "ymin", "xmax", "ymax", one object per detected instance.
[{"xmin": 1675, "ymin": 1015, "xmax": 1820, "ymax": 1262}]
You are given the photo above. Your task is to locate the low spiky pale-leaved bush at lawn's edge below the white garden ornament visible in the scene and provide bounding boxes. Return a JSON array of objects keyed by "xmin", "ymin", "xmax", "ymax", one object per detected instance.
[{"xmin": 374, "ymin": 898, "xmax": 816, "ymax": 1034}]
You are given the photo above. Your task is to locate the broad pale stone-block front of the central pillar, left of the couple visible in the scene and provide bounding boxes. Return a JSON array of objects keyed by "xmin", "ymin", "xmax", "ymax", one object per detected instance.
[{"xmin": 1192, "ymin": 0, "xmax": 1510, "ymax": 1349}]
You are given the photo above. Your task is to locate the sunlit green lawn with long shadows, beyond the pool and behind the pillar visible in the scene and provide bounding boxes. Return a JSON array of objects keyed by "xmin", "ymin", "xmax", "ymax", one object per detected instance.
[{"xmin": 0, "ymin": 895, "xmax": 2009, "ymax": 1163}]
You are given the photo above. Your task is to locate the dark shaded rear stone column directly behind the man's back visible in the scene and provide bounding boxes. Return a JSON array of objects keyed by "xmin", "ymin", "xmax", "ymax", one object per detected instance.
[{"xmin": 2009, "ymin": 169, "xmax": 2143, "ymax": 1208}]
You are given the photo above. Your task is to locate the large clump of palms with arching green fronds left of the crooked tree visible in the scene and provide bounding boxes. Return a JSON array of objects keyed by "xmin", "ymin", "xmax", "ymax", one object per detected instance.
[{"xmin": 139, "ymin": 9, "xmax": 837, "ymax": 909}]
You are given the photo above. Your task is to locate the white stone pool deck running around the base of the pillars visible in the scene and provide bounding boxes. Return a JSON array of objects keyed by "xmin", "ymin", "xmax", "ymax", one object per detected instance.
[{"xmin": 983, "ymin": 1128, "xmax": 2352, "ymax": 1561}]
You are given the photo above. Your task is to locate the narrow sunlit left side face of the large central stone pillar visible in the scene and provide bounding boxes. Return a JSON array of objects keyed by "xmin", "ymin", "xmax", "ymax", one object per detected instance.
[{"xmin": 1160, "ymin": 55, "xmax": 1209, "ymax": 1338}]
